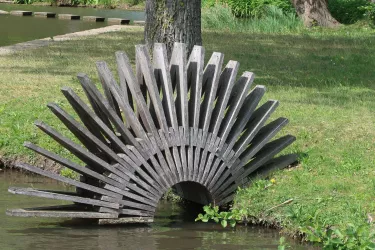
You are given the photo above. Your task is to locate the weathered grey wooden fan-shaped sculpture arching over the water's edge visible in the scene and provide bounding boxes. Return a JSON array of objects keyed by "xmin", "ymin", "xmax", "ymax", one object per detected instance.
[{"xmin": 7, "ymin": 43, "xmax": 296, "ymax": 221}]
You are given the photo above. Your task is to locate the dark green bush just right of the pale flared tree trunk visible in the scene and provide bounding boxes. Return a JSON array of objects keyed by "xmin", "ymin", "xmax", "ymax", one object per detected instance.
[{"xmin": 328, "ymin": 0, "xmax": 369, "ymax": 24}]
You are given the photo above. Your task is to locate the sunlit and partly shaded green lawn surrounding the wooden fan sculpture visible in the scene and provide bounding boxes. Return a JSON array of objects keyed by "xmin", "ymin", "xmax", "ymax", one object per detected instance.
[{"xmin": 0, "ymin": 26, "xmax": 375, "ymax": 242}]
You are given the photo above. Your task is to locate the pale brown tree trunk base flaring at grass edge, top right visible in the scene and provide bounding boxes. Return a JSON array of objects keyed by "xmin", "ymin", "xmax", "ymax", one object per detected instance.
[{"xmin": 291, "ymin": 0, "xmax": 340, "ymax": 28}]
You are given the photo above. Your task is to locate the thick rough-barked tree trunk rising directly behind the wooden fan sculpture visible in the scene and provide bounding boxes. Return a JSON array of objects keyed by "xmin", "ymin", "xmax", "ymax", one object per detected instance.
[{"xmin": 145, "ymin": 0, "xmax": 202, "ymax": 57}]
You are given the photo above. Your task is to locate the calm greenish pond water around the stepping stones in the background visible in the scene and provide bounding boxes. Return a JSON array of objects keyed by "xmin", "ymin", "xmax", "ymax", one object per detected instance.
[{"xmin": 0, "ymin": 3, "xmax": 145, "ymax": 46}]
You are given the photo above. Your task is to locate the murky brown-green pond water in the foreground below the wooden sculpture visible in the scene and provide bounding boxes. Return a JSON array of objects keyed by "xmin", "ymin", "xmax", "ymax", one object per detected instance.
[{"xmin": 0, "ymin": 171, "xmax": 313, "ymax": 250}]
